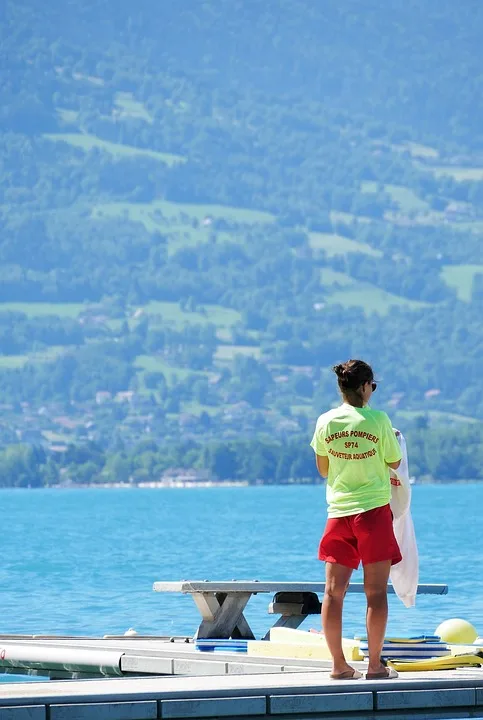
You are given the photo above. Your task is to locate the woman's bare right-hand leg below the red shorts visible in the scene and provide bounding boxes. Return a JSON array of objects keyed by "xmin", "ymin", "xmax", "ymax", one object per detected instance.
[{"xmin": 364, "ymin": 560, "xmax": 391, "ymax": 673}]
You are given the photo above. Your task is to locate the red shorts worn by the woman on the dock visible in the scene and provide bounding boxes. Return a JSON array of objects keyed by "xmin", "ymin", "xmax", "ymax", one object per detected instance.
[{"xmin": 319, "ymin": 505, "xmax": 402, "ymax": 570}]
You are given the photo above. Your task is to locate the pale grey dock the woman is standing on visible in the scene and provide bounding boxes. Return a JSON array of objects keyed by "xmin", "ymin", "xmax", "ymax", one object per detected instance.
[{"xmin": 0, "ymin": 636, "xmax": 483, "ymax": 720}]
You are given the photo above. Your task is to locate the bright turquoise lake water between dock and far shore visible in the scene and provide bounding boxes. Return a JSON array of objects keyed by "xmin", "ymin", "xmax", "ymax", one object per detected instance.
[{"xmin": 0, "ymin": 483, "xmax": 483, "ymax": 636}]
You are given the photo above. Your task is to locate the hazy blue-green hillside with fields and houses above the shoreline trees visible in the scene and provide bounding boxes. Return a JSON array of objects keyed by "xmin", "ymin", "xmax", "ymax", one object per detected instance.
[{"xmin": 0, "ymin": 0, "xmax": 483, "ymax": 484}]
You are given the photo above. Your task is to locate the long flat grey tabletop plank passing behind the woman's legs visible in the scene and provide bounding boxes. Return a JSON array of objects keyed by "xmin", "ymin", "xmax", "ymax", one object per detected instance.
[{"xmin": 153, "ymin": 580, "xmax": 448, "ymax": 595}]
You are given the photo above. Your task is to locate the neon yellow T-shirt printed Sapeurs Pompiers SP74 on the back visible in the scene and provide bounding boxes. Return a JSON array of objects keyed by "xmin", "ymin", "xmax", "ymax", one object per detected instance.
[{"xmin": 310, "ymin": 403, "xmax": 401, "ymax": 517}]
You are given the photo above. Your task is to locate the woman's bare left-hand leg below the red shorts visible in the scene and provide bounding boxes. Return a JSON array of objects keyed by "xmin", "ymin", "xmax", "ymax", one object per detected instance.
[{"xmin": 322, "ymin": 563, "xmax": 352, "ymax": 675}]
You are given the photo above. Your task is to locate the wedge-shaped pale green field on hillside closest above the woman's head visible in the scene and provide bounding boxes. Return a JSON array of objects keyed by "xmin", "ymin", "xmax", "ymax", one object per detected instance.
[{"xmin": 321, "ymin": 268, "xmax": 430, "ymax": 315}]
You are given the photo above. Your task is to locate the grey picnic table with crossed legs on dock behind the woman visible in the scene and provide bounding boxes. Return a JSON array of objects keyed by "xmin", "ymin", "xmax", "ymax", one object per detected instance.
[{"xmin": 153, "ymin": 580, "xmax": 448, "ymax": 640}]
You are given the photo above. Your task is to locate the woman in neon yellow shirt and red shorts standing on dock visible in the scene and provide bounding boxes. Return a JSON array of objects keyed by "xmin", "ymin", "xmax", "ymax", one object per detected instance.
[{"xmin": 311, "ymin": 360, "xmax": 401, "ymax": 680}]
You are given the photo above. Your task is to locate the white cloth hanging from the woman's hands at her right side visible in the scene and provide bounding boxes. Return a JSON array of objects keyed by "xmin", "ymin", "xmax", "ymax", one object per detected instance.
[{"xmin": 390, "ymin": 431, "xmax": 419, "ymax": 607}]
